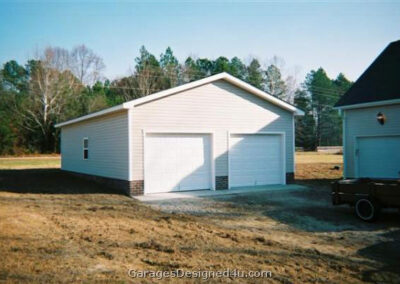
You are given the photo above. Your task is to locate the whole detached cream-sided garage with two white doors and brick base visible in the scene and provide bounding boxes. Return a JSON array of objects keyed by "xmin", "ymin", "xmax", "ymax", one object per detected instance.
[{"xmin": 56, "ymin": 73, "xmax": 303, "ymax": 195}]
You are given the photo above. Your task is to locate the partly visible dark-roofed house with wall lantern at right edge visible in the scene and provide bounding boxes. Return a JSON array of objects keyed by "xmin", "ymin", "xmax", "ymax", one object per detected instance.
[{"xmin": 335, "ymin": 41, "xmax": 400, "ymax": 178}]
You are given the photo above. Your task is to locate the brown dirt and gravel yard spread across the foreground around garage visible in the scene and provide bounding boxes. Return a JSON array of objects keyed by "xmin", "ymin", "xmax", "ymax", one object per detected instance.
[{"xmin": 0, "ymin": 154, "xmax": 400, "ymax": 283}]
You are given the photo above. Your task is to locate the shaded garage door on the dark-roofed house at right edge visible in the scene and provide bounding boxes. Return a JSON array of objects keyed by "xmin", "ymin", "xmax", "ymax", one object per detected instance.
[{"xmin": 357, "ymin": 136, "xmax": 400, "ymax": 178}]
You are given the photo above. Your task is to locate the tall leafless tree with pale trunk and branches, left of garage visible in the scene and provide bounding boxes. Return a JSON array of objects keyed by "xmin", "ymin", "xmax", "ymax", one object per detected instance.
[{"xmin": 16, "ymin": 47, "xmax": 82, "ymax": 152}]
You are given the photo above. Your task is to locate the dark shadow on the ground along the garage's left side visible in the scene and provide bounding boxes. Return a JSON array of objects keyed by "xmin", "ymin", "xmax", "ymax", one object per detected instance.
[{"xmin": 0, "ymin": 169, "xmax": 119, "ymax": 194}]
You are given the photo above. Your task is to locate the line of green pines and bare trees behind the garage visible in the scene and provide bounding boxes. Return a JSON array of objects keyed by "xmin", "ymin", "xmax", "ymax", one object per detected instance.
[{"xmin": 0, "ymin": 45, "xmax": 352, "ymax": 155}]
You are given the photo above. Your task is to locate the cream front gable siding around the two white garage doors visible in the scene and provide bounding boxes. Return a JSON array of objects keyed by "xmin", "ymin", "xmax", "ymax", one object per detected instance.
[{"xmin": 130, "ymin": 80, "xmax": 294, "ymax": 180}]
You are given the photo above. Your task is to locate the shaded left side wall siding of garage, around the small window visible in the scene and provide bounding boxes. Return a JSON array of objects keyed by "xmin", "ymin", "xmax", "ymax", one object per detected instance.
[{"xmin": 61, "ymin": 111, "xmax": 129, "ymax": 180}]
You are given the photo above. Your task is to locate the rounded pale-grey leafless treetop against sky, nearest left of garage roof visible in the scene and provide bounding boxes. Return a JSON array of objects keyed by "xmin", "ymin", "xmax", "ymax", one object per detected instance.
[{"xmin": 70, "ymin": 45, "xmax": 105, "ymax": 86}]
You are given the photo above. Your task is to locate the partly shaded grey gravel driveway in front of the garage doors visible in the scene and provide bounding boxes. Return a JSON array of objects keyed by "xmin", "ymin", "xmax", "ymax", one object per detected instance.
[{"xmin": 147, "ymin": 185, "xmax": 398, "ymax": 232}]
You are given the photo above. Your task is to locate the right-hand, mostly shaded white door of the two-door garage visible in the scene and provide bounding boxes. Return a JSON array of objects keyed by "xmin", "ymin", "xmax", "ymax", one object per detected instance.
[{"xmin": 229, "ymin": 134, "xmax": 285, "ymax": 187}]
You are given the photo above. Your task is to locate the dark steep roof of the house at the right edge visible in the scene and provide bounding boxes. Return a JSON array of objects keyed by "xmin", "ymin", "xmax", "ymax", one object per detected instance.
[{"xmin": 335, "ymin": 40, "xmax": 400, "ymax": 109}]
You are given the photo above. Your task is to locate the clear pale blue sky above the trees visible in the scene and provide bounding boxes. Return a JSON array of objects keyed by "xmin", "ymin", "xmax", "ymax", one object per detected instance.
[{"xmin": 0, "ymin": 0, "xmax": 400, "ymax": 81}]
